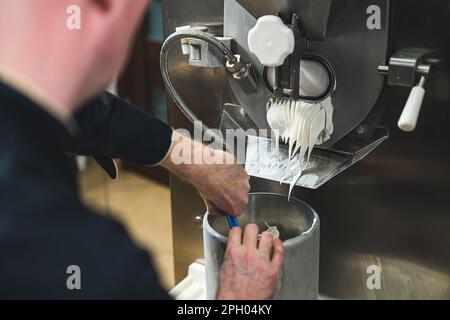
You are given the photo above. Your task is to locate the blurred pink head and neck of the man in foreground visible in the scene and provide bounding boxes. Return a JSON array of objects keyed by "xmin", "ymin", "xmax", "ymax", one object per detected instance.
[{"xmin": 0, "ymin": 0, "xmax": 149, "ymax": 114}]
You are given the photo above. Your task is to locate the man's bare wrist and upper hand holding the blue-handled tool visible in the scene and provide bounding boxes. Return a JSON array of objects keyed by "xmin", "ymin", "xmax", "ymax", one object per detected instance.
[{"xmin": 161, "ymin": 131, "xmax": 250, "ymax": 216}]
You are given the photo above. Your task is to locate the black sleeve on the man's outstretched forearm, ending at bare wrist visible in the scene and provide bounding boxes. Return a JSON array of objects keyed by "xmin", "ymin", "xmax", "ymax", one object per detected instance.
[{"xmin": 71, "ymin": 92, "xmax": 172, "ymax": 165}]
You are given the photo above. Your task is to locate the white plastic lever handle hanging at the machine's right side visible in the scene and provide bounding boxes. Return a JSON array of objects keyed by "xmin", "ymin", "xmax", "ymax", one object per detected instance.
[{"xmin": 398, "ymin": 77, "xmax": 426, "ymax": 132}]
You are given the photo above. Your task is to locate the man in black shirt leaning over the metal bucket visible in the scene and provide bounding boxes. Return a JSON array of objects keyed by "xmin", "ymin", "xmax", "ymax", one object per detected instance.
[{"xmin": 0, "ymin": 0, "xmax": 283, "ymax": 299}]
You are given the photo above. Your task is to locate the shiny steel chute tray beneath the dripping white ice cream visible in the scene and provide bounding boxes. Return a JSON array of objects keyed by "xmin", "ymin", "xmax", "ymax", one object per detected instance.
[{"xmin": 245, "ymin": 125, "xmax": 388, "ymax": 189}]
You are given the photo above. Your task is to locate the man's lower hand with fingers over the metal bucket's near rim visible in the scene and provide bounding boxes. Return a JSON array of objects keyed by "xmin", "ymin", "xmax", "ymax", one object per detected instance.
[{"xmin": 217, "ymin": 224, "xmax": 284, "ymax": 300}]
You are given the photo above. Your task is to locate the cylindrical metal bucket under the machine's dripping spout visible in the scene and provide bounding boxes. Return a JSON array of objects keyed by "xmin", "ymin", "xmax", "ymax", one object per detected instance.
[{"xmin": 203, "ymin": 193, "xmax": 320, "ymax": 300}]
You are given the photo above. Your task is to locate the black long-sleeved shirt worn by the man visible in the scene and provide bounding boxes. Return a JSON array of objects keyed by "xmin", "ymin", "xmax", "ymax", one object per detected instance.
[{"xmin": 0, "ymin": 83, "xmax": 172, "ymax": 299}]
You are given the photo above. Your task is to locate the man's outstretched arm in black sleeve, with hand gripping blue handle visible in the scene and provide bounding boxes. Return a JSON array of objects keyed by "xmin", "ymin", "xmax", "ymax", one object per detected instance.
[{"xmin": 72, "ymin": 93, "xmax": 250, "ymax": 215}]
